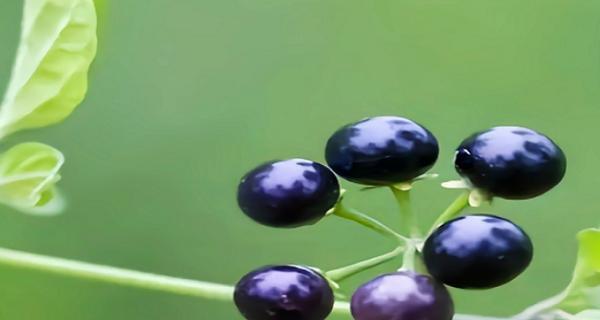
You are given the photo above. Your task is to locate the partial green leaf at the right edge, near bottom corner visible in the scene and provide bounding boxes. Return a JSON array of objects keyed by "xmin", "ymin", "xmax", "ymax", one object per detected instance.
[{"xmin": 557, "ymin": 229, "xmax": 600, "ymax": 314}]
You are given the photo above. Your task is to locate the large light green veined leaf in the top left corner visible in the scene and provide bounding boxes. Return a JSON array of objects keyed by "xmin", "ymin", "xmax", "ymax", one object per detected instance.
[{"xmin": 0, "ymin": 0, "xmax": 97, "ymax": 137}]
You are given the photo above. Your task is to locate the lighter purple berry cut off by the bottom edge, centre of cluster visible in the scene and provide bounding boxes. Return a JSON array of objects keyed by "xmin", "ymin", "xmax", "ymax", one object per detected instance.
[{"xmin": 350, "ymin": 271, "xmax": 454, "ymax": 320}]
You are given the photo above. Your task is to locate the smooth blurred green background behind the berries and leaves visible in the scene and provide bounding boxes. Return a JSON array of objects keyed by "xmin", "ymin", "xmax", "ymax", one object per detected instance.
[{"xmin": 0, "ymin": 0, "xmax": 600, "ymax": 320}]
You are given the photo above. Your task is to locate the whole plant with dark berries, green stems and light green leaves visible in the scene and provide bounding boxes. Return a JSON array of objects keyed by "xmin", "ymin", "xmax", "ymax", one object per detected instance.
[{"xmin": 0, "ymin": 0, "xmax": 600, "ymax": 320}]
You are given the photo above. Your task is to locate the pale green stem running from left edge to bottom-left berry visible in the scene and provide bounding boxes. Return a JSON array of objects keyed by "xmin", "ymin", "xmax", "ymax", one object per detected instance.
[{"xmin": 0, "ymin": 248, "xmax": 233, "ymax": 301}]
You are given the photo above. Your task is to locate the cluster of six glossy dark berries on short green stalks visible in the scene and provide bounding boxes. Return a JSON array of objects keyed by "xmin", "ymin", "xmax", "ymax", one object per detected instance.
[{"xmin": 234, "ymin": 116, "xmax": 566, "ymax": 320}]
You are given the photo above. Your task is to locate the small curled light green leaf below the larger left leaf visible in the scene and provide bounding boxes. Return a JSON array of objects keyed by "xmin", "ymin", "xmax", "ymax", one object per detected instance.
[{"xmin": 0, "ymin": 142, "xmax": 64, "ymax": 214}]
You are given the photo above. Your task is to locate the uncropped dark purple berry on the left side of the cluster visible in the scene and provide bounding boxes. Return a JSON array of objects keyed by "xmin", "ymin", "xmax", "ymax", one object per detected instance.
[{"xmin": 238, "ymin": 159, "xmax": 340, "ymax": 228}]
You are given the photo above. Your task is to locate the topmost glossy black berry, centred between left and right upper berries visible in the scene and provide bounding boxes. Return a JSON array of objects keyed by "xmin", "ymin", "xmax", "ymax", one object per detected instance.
[{"xmin": 325, "ymin": 116, "xmax": 439, "ymax": 185}]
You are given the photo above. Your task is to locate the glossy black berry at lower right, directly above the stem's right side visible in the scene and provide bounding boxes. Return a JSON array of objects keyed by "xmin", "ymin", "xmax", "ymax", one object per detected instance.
[{"xmin": 423, "ymin": 214, "xmax": 533, "ymax": 289}]
